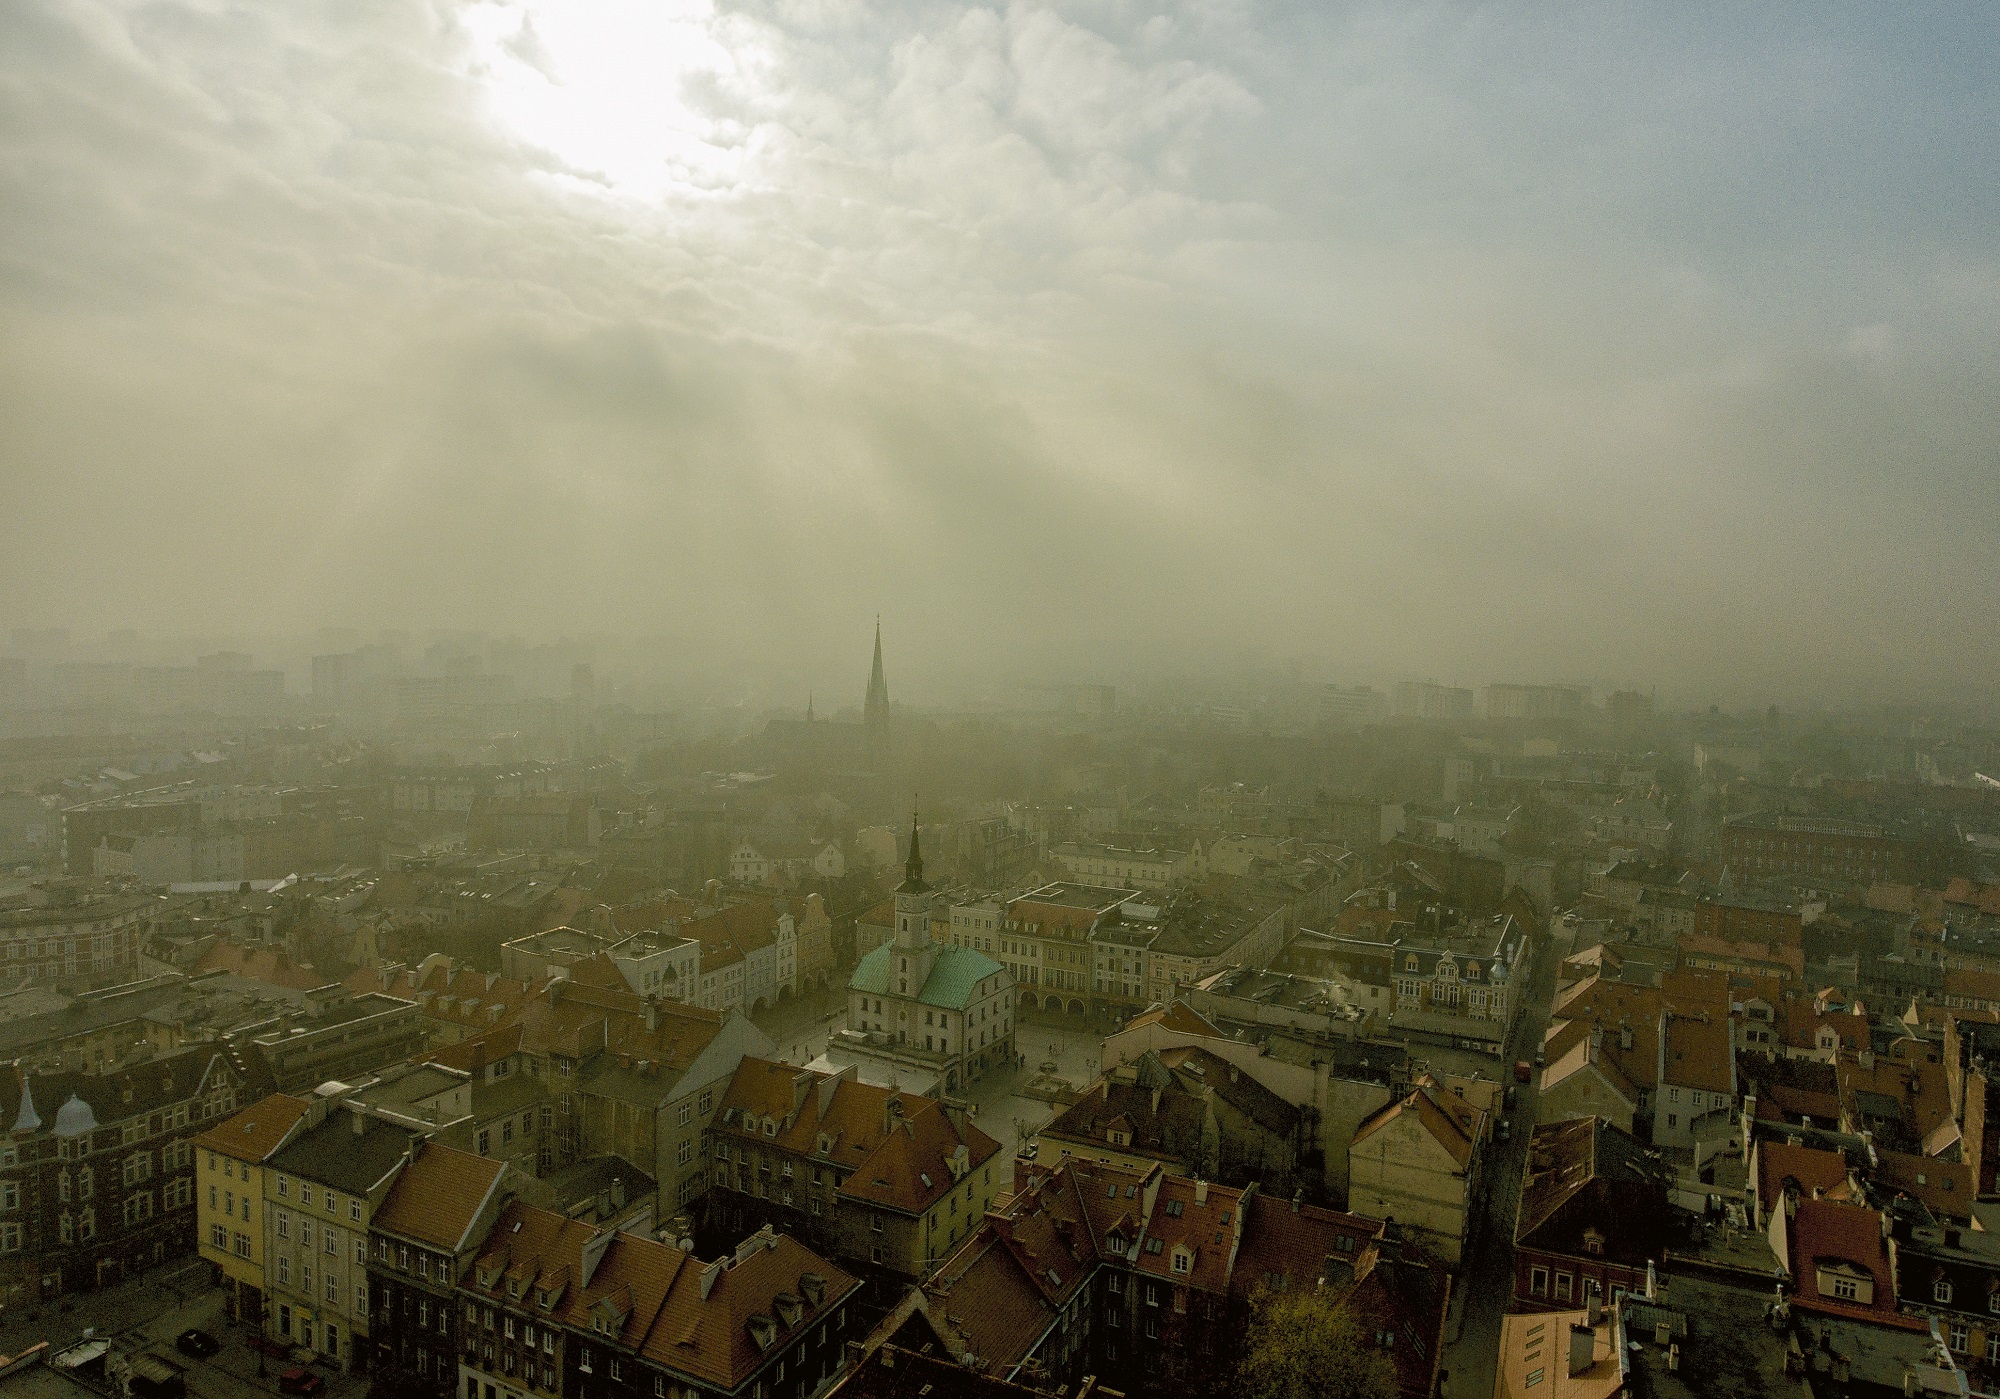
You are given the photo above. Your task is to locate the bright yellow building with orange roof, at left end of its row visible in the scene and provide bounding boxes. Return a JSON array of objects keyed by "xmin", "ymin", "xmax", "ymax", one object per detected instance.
[{"xmin": 194, "ymin": 1093, "xmax": 312, "ymax": 1325}]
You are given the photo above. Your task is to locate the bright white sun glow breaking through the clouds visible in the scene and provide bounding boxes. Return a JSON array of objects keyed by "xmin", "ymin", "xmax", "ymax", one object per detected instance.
[{"xmin": 460, "ymin": 0, "xmax": 760, "ymax": 200}]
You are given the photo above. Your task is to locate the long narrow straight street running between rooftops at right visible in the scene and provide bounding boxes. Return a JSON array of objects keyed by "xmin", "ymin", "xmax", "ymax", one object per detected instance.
[{"xmin": 1442, "ymin": 923, "xmax": 1574, "ymax": 1399}]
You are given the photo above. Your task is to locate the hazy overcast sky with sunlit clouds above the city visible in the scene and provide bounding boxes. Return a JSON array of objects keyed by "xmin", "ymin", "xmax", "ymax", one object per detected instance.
[{"xmin": 0, "ymin": 0, "xmax": 2000, "ymax": 698}]
